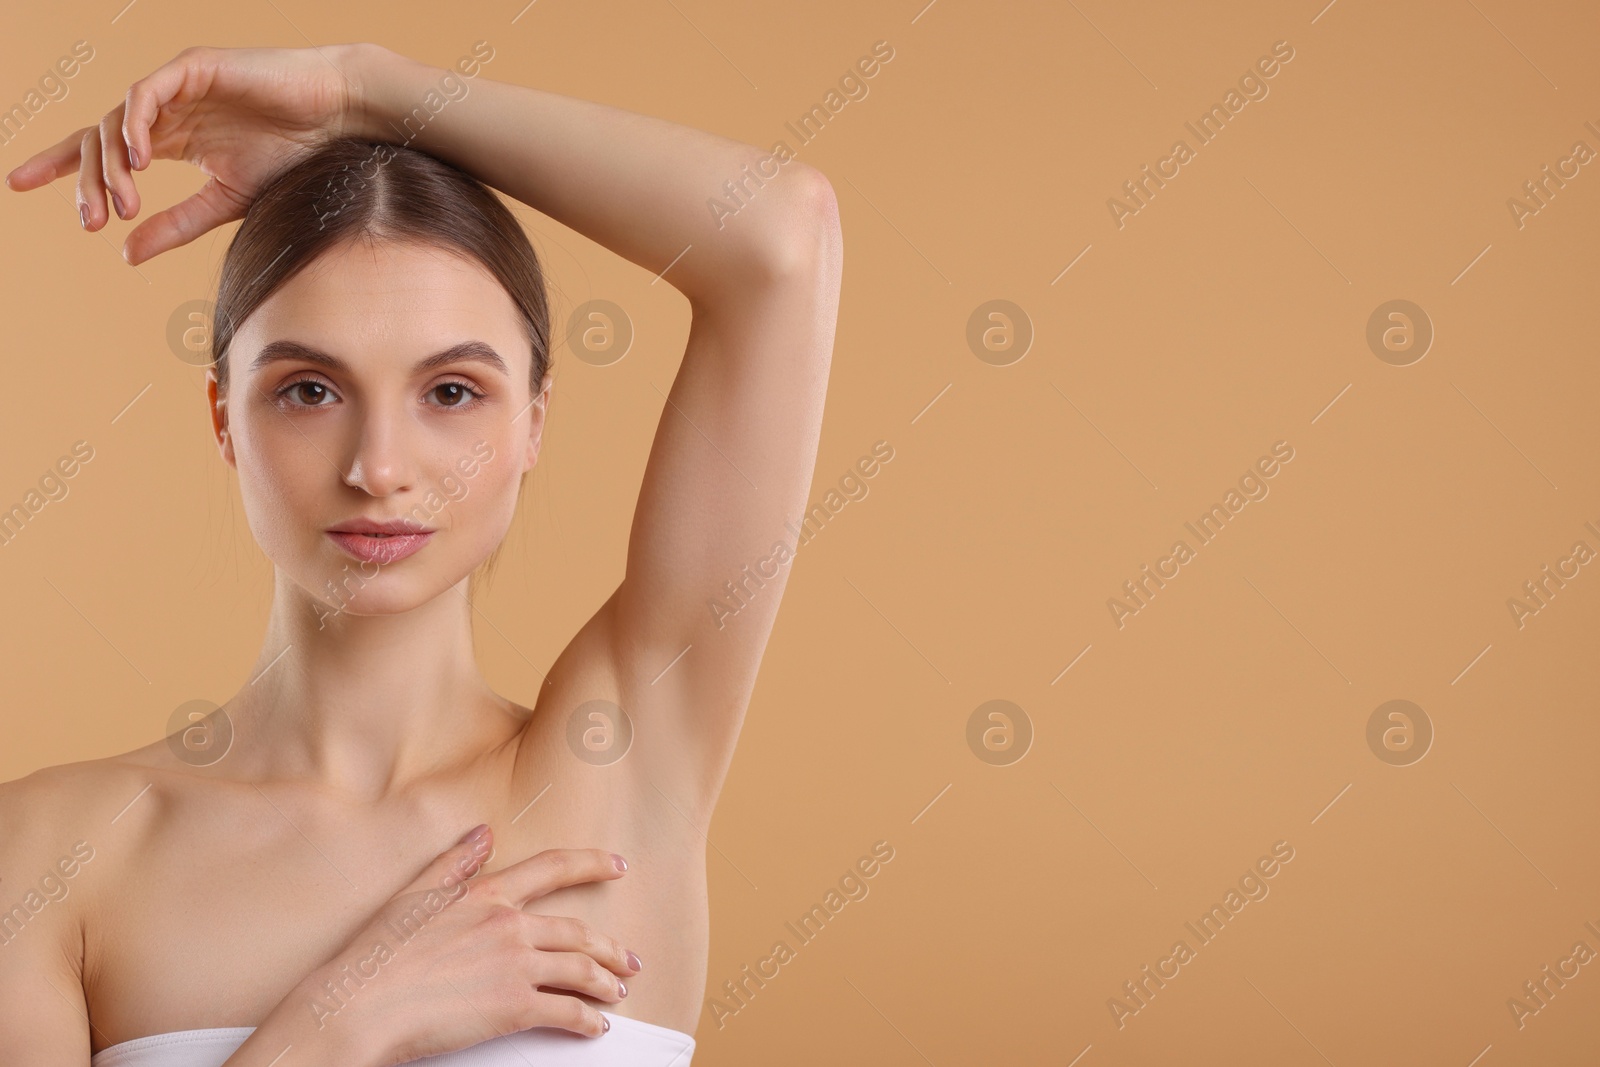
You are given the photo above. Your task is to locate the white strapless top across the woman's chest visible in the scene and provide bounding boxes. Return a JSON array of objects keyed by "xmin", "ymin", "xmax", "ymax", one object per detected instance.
[{"xmin": 90, "ymin": 1011, "xmax": 694, "ymax": 1067}]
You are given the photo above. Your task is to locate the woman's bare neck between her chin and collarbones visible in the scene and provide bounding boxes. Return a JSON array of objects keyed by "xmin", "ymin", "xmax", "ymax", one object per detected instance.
[{"xmin": 227, "ymin": 573, "xmax": 522, "ymax": 798}]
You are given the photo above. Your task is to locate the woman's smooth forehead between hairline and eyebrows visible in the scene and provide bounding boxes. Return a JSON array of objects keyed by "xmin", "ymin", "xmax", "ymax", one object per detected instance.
[{"xmin": 235, "ymin": 240, "xmax": 533, "ymax": 360}]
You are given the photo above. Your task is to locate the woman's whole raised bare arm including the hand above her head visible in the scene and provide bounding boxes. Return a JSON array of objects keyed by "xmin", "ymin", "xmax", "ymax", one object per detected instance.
[{"xmin": 6, "ymin": 37, "xmax": 842, "ymax": 803}]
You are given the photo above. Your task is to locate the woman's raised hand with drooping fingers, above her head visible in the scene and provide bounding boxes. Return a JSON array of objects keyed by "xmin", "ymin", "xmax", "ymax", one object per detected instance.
[{"xmin": 6, "ymin": 45, "xmax": 374, "ymax": 264}]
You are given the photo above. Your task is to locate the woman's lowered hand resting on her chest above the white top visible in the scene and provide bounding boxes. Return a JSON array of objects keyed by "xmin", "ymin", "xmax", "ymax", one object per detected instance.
[{"xmin": 274, "ymin": 827, "xmax": 638, "ymax": 1064}]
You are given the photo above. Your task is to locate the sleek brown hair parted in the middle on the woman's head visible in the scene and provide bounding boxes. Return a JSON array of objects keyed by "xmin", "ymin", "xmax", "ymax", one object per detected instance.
[{"xmin": 211, "ymin": 138, "xmax": 550, "ymax": 394}]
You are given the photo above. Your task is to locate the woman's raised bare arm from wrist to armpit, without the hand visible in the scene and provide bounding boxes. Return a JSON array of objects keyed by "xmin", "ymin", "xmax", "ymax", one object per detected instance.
[{"xmin": 344, "ymin": 50, "xmax": 842, "ymax": 803}]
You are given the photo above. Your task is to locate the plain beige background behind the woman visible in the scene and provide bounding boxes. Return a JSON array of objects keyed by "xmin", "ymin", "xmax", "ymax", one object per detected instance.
[{"xmin": 0, "ymin": 0, "xmax": 1600, "ymax": 1067}]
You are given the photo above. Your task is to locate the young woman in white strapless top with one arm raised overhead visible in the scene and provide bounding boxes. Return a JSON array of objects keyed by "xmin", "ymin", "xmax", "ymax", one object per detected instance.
[{"xmin": 0, "ymin": 45, "xmax": 842, "ymax": 1067}]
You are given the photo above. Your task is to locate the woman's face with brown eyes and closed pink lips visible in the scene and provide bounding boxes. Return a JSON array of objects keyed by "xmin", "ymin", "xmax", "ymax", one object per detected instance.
[{"xmin": 211, "ymin": 240, "xmax": 549, "ymax": 624}]
